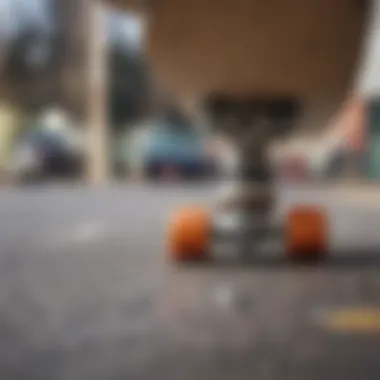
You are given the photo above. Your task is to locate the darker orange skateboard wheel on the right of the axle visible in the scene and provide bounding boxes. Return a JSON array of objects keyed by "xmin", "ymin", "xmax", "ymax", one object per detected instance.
[{"xmin": 286, "ymin": 206, "xmax": 328, "ymax": 260}]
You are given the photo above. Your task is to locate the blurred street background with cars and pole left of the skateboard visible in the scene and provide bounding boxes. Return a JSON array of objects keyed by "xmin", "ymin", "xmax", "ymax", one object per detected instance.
[{"xmin": 0, "ymin": 0, "xmax": 220, "ymax": 185}]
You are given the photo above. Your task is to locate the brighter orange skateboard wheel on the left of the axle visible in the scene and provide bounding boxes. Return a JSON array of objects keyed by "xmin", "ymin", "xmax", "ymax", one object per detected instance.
[{"xmin": 169, "ymin": 207, "xmax": 212, "ymax": 261}]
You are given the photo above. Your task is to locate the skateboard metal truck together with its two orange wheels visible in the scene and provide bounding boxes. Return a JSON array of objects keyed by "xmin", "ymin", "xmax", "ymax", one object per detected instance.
[{"xmin": 168, "ymin": 94, "xmax": 328, "ymax": 262}]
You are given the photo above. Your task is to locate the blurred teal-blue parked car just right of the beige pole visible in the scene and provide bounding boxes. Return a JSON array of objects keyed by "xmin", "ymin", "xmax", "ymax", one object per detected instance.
[{"xmin": 119, "ymin": 113, "xmax": 216, "ymax": 179}]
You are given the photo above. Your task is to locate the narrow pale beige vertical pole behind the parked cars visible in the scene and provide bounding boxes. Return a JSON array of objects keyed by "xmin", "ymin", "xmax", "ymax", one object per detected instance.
[{"xmin": 85, "ymin": 0, "xmax": 109, "ymax": 185}]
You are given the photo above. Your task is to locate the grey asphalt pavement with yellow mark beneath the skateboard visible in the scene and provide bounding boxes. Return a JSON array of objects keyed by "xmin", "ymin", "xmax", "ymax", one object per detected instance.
[{"xmin": 0, "ymin": 185, "xmax": 380, "ymax": 380}]
